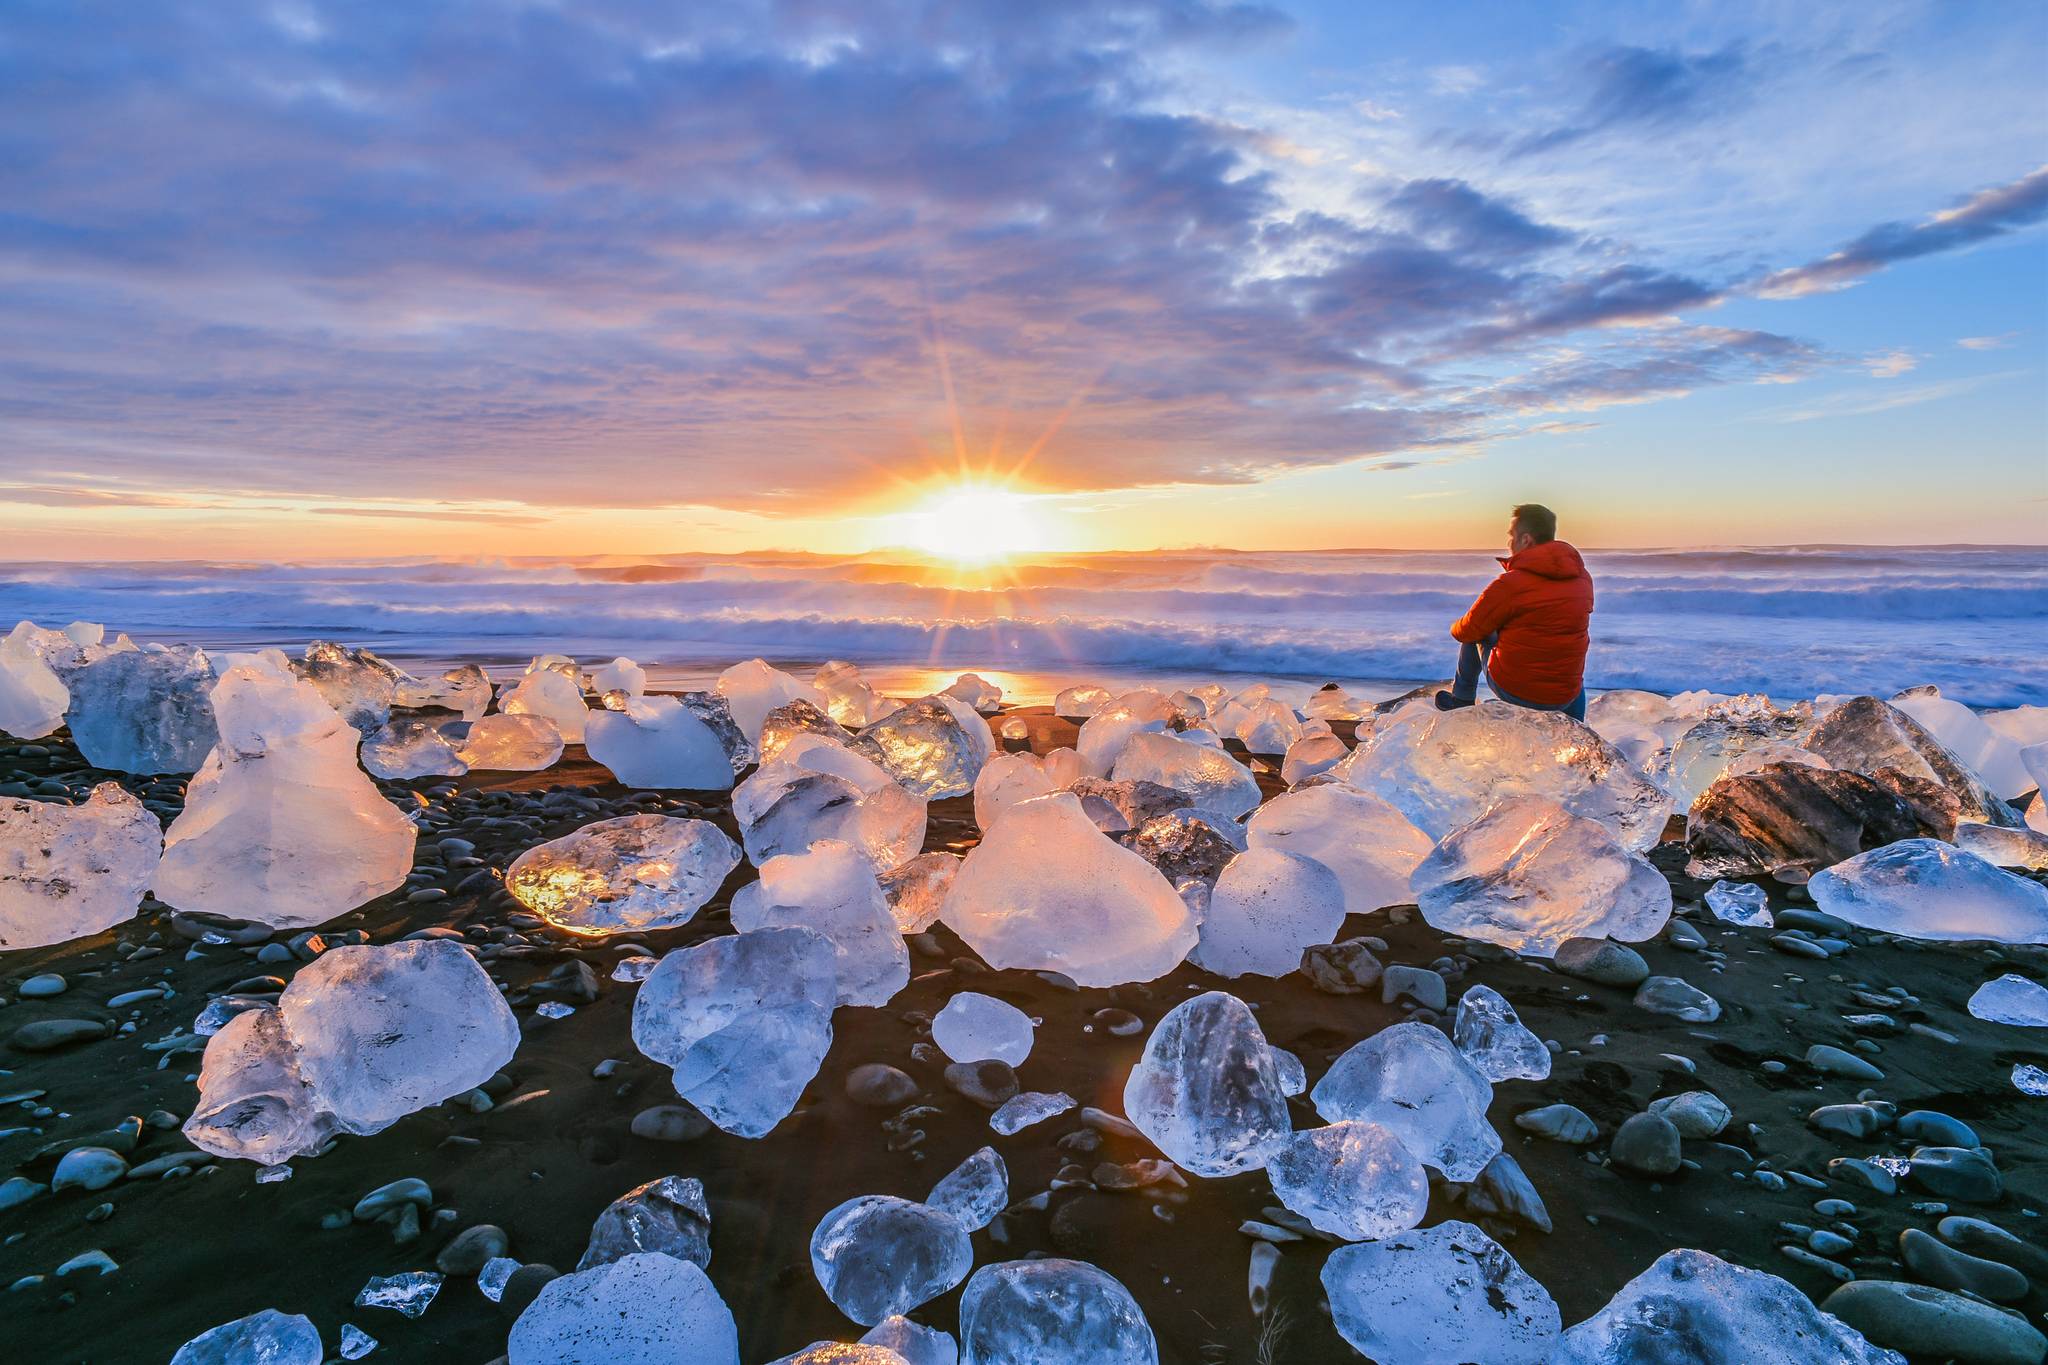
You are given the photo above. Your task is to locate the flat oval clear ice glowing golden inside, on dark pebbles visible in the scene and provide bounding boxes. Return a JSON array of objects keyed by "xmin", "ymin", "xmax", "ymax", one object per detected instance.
[{"xmin": 506, "ymin": 814, "xmax": 739, "ymax": 937}]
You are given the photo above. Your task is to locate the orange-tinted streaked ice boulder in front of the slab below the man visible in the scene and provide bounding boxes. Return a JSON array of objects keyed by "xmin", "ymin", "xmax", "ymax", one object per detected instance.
[{"xmin": 1411, "ymin": 796, "xmax": 1671, "ymax": 958}]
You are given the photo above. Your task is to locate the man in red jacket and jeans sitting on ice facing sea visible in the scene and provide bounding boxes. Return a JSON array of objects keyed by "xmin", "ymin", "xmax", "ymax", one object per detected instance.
[{"xmin": 1436, "ymin": 503, "xmax": 1593, "ymax": 720}]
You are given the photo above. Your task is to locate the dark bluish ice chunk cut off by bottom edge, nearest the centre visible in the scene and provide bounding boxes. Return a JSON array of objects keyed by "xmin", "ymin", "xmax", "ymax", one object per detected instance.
[{"xmin": 961, "ymin": 1257, "xmax": 1159, "ymax": 1365}]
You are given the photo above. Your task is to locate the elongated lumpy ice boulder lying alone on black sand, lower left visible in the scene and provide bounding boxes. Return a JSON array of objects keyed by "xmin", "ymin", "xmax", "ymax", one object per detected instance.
[{"xmin": 184, "ymin": 939, "xmax": 518, "ymax": 1164}]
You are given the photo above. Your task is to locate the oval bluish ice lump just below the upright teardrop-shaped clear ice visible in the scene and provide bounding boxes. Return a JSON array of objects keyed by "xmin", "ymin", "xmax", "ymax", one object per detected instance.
[{"xmin": 1266, "ymin": 1119, "xmax": 1430, "ymax": 1242}]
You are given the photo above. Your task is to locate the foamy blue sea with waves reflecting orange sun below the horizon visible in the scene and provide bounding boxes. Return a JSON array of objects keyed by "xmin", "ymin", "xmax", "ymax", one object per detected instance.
[{"xmin": 0, "ymin": 546, "xmax": 2048, "ymax": 706}]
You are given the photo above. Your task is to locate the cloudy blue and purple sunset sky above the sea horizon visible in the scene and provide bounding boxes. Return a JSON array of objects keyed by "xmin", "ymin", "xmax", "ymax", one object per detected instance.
[{"xmin": 0, "ymin": 0, "xmax": 2048, "ymax": 559}]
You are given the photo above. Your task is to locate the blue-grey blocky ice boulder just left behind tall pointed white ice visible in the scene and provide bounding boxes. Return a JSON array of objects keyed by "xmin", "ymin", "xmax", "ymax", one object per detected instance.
[{"xmin": 70, "ymin": 647, "xmax": 218, "ymax": 774}]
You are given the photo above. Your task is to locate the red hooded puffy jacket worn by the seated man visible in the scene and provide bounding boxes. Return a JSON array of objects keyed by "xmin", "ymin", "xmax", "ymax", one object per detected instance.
[{"xmin": 1450, "ymin": 540, "xmax": 1593, "ymax": 706}]
